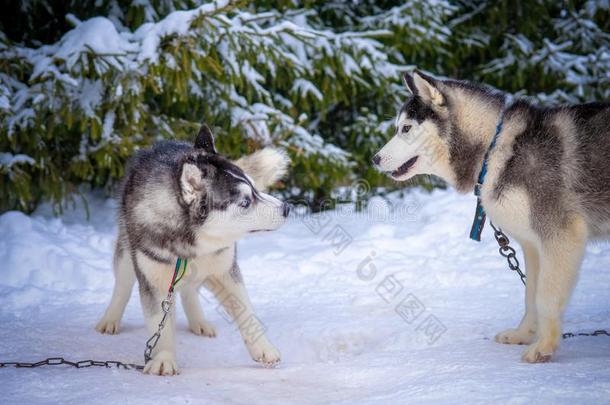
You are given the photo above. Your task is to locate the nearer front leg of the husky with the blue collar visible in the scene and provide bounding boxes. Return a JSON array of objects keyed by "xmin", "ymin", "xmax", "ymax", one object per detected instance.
[{"xmin": 523, "ymin": 217, "xmax": 587, "ymax": 363}]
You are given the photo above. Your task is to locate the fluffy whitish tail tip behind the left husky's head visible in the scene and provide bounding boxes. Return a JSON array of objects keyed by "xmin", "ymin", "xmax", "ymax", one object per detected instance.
[{"xmin": 234, "ymin": 148, "xmax": 290, "ymax": 191}]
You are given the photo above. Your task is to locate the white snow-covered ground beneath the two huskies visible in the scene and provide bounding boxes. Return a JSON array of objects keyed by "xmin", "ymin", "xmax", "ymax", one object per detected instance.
[{"xmin": 0, "ymin": 191, "xmax": 610, "ymax": 404}]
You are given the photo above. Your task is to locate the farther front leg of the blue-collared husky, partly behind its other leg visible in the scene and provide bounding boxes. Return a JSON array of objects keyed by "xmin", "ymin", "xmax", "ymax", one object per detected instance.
[{"xmin": 496, "ymin": 242, "xmax": 540, "ymax": 345}]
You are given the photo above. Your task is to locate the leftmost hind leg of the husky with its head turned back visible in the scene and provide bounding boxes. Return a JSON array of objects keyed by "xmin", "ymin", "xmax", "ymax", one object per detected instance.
[{"xmin": 95, "ymin": 236, "xmax": 136, "ymax": 335}]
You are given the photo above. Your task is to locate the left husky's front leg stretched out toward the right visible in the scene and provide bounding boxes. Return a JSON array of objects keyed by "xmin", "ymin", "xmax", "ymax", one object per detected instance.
[{"xmin": 205, "ymin": 263, "xmax": 280, "ymax": 366}]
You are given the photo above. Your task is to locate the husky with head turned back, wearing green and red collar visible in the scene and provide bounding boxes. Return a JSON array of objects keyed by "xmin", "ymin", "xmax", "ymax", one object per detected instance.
[{"xmin": 96, "ymin": 125, "xmax": 289, "ymax": 375}]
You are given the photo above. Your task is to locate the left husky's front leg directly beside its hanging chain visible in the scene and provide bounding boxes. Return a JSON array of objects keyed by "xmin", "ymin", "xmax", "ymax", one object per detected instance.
[{"xmin": 136, "ymin": 255, "xmax": 178, "ymax": 375}]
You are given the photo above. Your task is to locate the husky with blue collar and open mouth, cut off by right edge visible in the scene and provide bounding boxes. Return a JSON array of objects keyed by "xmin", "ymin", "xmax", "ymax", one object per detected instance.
[{"xmin": 373, "ymin": 71, "xmax": 610, "ymax": 363}]
